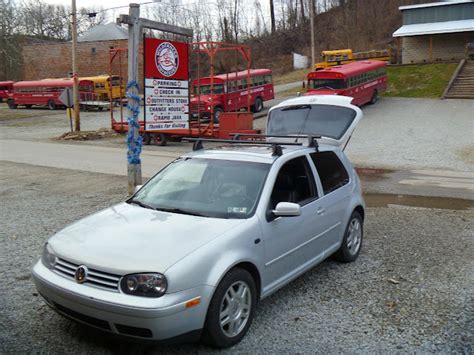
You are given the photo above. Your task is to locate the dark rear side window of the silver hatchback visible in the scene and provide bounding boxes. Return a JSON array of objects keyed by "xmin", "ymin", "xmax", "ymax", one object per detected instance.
[{"xmin": 310, "ymin": 152, "xmax": 349, "ymax": 195}]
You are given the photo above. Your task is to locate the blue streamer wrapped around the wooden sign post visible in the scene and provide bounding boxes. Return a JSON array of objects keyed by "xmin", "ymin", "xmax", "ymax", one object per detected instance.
[{"xmin": 126, "ymin": 80, "xmax": 143, "ymax": 164}]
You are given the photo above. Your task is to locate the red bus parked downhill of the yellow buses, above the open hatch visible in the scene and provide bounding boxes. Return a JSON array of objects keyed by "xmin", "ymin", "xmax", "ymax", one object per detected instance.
[{"xmin": 304, "ymin": 60, "xmax": 387, "ymax": 106}]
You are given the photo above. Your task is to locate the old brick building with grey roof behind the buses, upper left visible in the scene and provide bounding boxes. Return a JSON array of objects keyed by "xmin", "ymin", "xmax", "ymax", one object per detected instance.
[{"xmin": 22, "ymin": 23, "xmax": 143, "ymax": 80}]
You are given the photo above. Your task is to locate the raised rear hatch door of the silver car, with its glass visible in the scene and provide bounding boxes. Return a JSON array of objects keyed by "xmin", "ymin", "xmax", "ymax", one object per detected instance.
[{"xmin": 267, "ymin": 96, "xmax": 362, "ymax": 149}]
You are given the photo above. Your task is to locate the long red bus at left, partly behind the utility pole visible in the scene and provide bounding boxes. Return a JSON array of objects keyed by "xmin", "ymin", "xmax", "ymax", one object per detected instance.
[{"xmin": 7, "ymin": 79, "xmax": 95, "ymax": 110}]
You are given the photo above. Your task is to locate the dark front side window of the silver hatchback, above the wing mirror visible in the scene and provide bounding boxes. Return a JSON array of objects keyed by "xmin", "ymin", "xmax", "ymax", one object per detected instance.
[{"xmin": 270, "ymin": 156, "xmax": 317, "ymax": 210}]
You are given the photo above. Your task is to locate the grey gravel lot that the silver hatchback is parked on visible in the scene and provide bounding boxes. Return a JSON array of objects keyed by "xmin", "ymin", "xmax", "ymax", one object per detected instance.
[{"xmin": 0, "ymin": 162, "xmax": 474, "ymax": 354}]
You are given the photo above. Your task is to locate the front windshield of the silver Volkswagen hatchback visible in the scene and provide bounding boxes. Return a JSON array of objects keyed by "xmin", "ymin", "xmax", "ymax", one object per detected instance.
[{"xmin": 127, "ymin": 158, "xmax": 270, "ymax": 219}]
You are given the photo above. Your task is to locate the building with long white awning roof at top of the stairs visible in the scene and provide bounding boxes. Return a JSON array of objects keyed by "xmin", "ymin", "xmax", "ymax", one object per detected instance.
[{"xmin": 393, "ymin": 0, "xmax": 474, "ymax": 64}]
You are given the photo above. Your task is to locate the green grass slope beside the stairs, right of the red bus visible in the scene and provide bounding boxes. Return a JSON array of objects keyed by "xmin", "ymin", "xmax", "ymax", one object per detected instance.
[{"xmin": 383, "ymin": 63, "xmax": 458, "ymax": 98}]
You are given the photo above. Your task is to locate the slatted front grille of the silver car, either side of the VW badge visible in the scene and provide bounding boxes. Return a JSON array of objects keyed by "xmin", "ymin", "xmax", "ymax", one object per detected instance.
[{"xmin": 54, "ymin": 258, "xmax": 120, "ymax": 292}]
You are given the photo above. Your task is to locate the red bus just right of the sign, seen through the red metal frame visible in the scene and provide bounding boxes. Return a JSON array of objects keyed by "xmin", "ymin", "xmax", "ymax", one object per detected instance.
[{"xmin": 190, "ymin": 69, "xmax": 274, "ymax": 122}]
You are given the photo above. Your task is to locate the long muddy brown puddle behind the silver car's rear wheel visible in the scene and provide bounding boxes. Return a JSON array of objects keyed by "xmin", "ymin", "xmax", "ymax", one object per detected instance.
[{"xmin": 364, "ymin": 194, "xmax": 474, "ymax": 210}]
